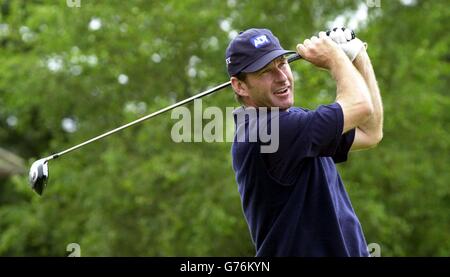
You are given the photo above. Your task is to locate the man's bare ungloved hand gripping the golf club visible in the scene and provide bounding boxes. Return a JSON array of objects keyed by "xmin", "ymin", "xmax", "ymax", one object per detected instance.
[{"xmin": 297, "ymin": 32, "xmax": 346, "ymax": 69}]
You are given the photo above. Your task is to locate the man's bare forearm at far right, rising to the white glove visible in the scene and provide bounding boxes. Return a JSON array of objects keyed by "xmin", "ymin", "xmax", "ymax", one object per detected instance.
[{"xmin": 350, "ymin": 49, "xmax": 383, "ymax": 151}]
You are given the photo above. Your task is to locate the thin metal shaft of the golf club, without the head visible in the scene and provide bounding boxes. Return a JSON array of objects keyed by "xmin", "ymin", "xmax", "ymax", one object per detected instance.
[{"xmin": 46, "ymin": 54, "xmax": 301, "ymax": 161}]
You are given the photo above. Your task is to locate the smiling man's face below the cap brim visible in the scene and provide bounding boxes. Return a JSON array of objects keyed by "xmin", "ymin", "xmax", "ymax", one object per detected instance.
[{"xmin": 236, "ymin": 57, "xmax": 294, "ymax": 110}]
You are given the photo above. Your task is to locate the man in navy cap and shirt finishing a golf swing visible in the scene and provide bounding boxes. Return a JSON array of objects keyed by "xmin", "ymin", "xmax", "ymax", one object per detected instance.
[{"xmin": 226, "ymin": 29, "xmax": 383, "ymax": 257}]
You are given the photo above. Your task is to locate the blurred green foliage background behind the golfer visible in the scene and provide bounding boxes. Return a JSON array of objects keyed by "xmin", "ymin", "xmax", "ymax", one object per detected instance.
[{"xmin": 0, "ymin": 0, "xmax": 450, "ymax": 256}]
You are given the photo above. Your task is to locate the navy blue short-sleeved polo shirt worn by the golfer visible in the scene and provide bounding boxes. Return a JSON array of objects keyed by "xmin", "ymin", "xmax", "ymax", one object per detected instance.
[{"xmin": 232, "ymin": 103, "xmax": 369, "ymax": 257}]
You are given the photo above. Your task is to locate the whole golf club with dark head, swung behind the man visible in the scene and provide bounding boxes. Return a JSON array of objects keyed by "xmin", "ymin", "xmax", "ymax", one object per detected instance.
[{"xmin": 29, "ymin": 28, "xmax": 355, "ymax": 195}]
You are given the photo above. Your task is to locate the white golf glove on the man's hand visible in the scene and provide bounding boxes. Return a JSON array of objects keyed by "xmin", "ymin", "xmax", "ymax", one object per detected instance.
[{"xmin": 329, "ymin": 28, "xmax": 367, "ymax": 62}]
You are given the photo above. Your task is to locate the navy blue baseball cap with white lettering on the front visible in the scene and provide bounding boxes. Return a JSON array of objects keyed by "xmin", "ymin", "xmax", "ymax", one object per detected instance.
[{"xmin": 225, "ymin": 29, "xmax": 296, "ymax": 77}]
